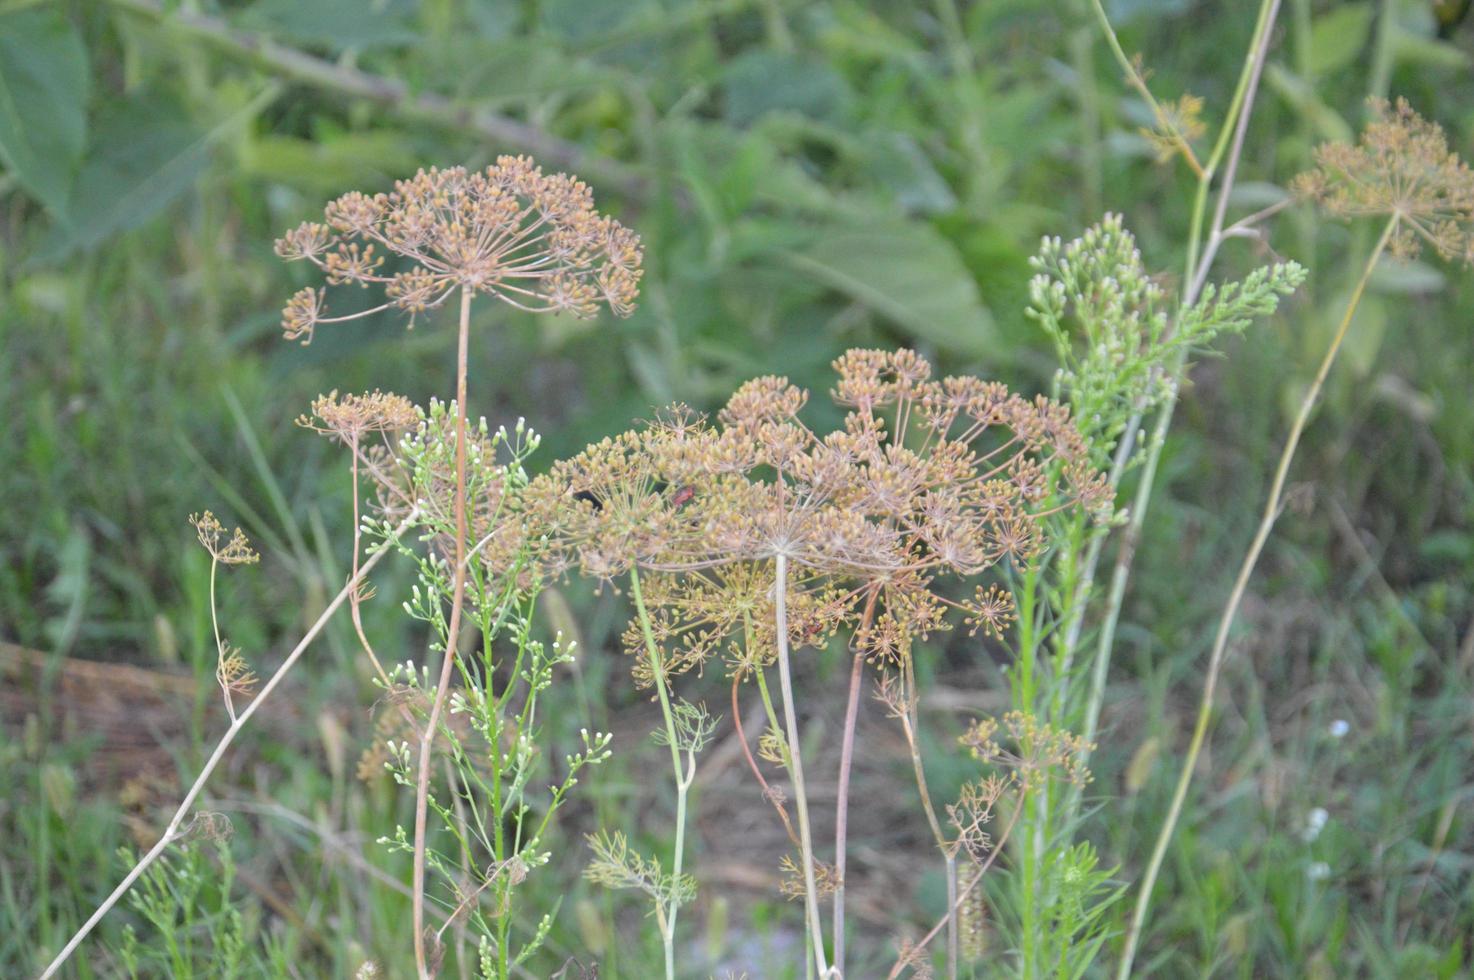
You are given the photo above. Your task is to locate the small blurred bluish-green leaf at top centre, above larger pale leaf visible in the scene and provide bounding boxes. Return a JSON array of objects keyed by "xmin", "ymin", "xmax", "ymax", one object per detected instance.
[{"xmin": 722, "ymin": 50, "xmax": 852, "ymax": 125}]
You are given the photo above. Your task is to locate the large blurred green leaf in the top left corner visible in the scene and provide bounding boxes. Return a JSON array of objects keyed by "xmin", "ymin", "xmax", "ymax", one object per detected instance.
[{"xmin": 0, "ymin": 6, "xmax": 90, "ymax": 220}]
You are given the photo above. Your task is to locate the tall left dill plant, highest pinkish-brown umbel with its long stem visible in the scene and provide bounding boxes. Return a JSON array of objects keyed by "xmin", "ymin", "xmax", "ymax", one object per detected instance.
[{"xmin": 277, "ymin": 156, "xmax": 643, "ymax": 980}]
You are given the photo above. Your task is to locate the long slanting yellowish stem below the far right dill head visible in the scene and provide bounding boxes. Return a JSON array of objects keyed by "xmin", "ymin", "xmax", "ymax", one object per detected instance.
[{"xmin": 1116, "ymin": 214, "xmax": 1397, "ymax": 980}]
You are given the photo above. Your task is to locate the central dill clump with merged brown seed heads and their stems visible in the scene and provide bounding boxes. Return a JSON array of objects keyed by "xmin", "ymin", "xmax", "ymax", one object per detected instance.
[{"xmin": 526, "ymin": 351, "xmax": 1104, "ymax": 976}]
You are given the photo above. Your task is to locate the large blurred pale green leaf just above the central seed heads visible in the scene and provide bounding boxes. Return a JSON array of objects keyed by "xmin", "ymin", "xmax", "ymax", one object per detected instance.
[{"xmin": 787, "ymin": 220, "xmax": 996, "ymax": 355}]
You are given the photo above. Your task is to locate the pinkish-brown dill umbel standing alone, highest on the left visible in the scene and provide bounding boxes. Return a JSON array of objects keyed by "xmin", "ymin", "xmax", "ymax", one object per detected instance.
[{"xmin": 276, "ymin": 156, "xmax": 643, "ymax": 343}]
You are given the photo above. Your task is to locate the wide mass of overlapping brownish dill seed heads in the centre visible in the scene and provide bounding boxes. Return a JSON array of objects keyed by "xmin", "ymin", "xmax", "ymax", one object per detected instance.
[{"xmin": 525, "ymin": 351, "xmax": 1108, "ymax": 682}]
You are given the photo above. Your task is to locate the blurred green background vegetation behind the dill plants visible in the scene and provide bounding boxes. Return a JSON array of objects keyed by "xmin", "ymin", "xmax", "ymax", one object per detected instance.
[{"xmin": 0, "ymin": 0, "xmax": 1474, "ymax": 977}]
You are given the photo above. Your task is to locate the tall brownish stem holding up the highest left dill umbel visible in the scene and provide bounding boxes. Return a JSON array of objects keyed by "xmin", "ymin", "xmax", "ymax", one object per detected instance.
[{"xmin": 411, "ymin": 286, "xmax": 468, "ymax": 980}]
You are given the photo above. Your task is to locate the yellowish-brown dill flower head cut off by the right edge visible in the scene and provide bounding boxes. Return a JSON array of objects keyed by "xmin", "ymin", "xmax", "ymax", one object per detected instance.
[{"xmin": 1294, "ymin": 99, "xmax": 1474, "ymax": 265}]
